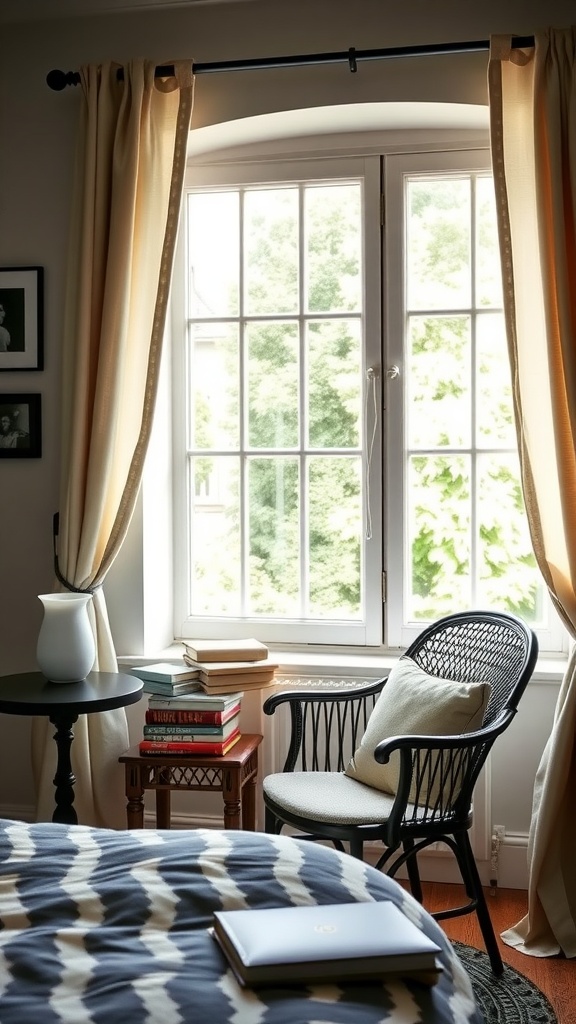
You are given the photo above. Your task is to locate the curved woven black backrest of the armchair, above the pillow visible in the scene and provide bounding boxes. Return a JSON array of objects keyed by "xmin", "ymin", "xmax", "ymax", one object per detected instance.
[{"xmin": 406, "ymin": 611, "xmax": 538, "ymax": 728}]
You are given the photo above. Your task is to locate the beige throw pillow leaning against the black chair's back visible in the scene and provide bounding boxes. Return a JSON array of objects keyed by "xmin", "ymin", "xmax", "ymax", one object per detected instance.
[{"xmin": 344, "ymin": 657, "xmax": 490, "ymax": 800}]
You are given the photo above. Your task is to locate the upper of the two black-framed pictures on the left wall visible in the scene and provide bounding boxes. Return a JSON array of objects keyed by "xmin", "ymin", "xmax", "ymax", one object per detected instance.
[{"xmin": 0, "ymin": 266, "xmax": 44, "ymax": 370}]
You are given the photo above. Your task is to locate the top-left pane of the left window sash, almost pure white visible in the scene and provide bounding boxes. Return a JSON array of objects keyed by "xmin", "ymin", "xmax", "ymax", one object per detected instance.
[{"xmin": 188, "ymin": 191, "xmax": 240, "ymax": 316}]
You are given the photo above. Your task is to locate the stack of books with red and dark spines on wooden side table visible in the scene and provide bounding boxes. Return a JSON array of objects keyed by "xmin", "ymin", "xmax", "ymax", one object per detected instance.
[{"xmin": 138, "ymin": 690, "xmax": 242, "ymax": 757}]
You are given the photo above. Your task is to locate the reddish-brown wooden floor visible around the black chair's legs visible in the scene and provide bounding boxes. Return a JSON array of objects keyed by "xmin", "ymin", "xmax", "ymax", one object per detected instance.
[{"xmin": 412, "ymin": 882, "xmax": 576, "ymax": 1024}]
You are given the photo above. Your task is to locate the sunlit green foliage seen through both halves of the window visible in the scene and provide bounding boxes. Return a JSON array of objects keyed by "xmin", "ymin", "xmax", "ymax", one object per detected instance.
[{"xmin": 190, "ymin": 175, "xmax": 539, "ymax": 621}]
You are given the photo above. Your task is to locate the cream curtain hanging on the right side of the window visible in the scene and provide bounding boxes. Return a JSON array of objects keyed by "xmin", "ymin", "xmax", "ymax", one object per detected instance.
[{"xmin": 489, "ymin": 29, "xmax": 576, "ymax": 956}]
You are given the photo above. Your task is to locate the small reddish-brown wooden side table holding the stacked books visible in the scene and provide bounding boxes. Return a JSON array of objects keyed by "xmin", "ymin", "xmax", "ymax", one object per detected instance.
[{"xmin": 118, "ymin": 734, "xmax": 262, "ymax": 831}]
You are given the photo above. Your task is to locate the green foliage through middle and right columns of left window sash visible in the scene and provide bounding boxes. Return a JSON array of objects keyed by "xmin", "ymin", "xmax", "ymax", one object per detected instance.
[{"xmin": 239, "ymin": 186, "xmax": 362, "ymax": 617}]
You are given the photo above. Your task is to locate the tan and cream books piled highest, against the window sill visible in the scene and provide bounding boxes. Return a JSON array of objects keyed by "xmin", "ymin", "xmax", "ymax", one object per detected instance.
[{"xmin": 183, "ymin": 640, "xmax": 278, "ymax": 693}]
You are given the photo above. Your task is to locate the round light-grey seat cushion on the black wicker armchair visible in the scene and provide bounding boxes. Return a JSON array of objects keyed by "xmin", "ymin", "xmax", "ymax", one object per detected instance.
[{"xmin": 262, "ymin": 771, "xmax": 394, "ymax": 824}]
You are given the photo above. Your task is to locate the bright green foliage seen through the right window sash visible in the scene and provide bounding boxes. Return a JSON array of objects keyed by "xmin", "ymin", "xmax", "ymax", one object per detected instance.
[{"xmin": 408, "ymin": 178, "xmax": 539, "ymax": 621}]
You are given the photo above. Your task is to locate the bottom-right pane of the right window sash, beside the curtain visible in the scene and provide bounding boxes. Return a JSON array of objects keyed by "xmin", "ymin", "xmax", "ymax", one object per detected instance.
[{"xmin": 478, "ymin": 455, "xmax": 543, "ymax": 624}]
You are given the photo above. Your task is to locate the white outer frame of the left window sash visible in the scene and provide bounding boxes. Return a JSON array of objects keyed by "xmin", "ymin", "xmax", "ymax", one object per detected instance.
[{"xmin": 172, "ymin": 155, "xmax": 382, "ymax": 647}]
